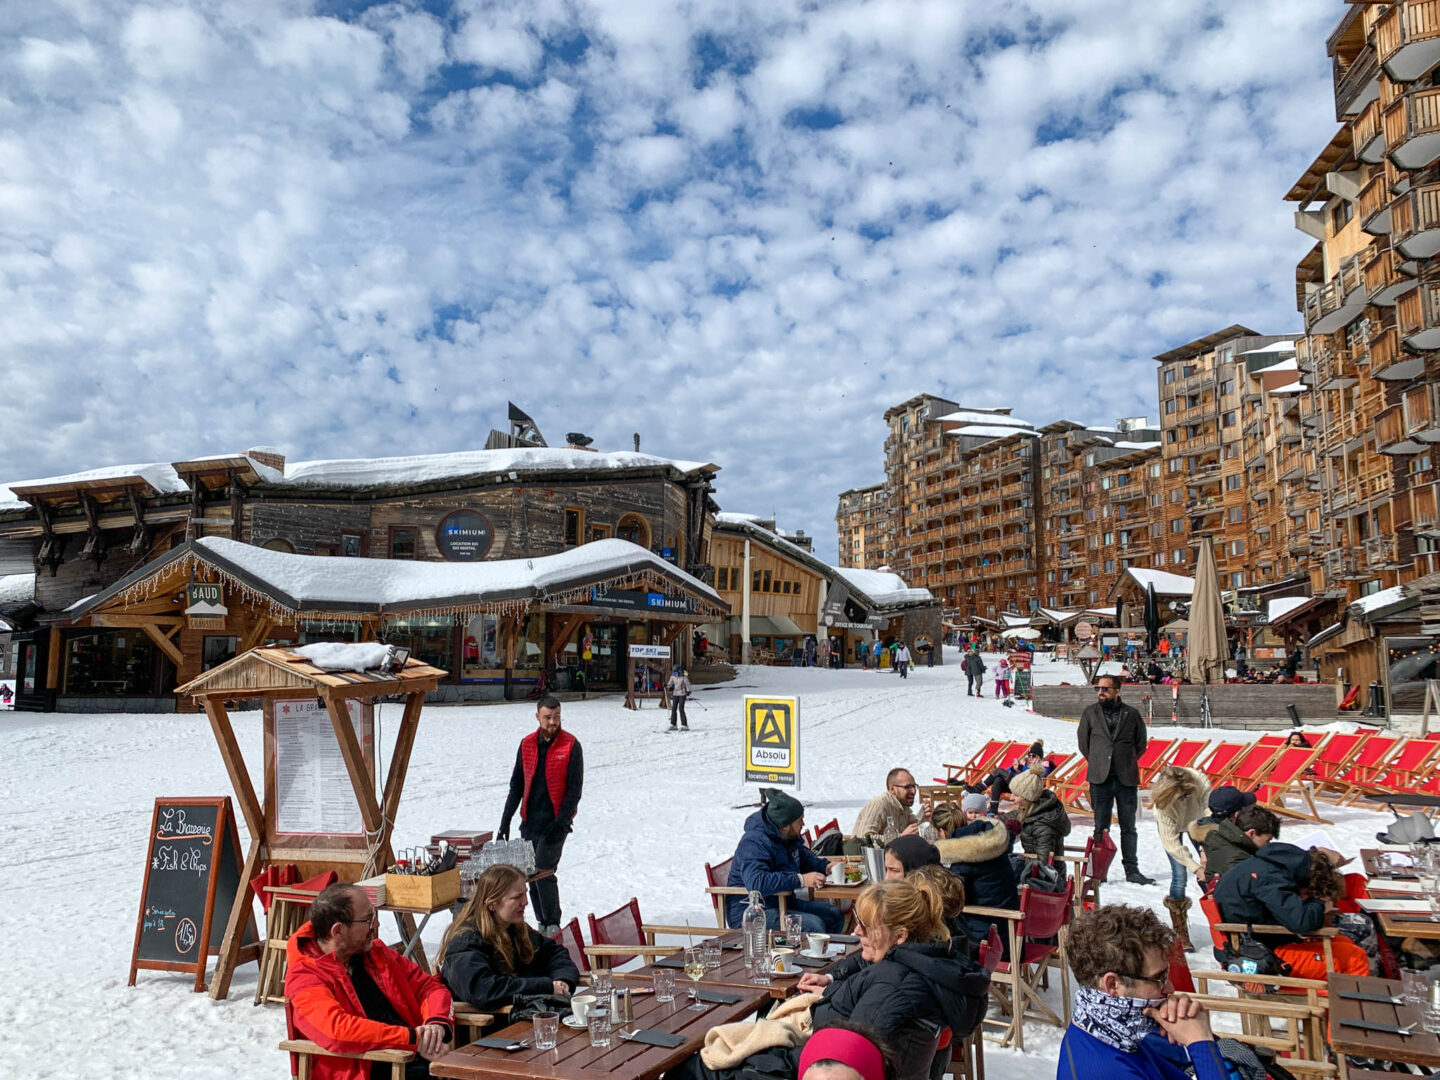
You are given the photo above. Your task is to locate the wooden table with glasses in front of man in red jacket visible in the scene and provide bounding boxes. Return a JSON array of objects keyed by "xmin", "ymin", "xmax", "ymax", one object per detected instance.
[{"xmin": 431, "ymin": 985, "xmax": 768, "ymax": 1080}]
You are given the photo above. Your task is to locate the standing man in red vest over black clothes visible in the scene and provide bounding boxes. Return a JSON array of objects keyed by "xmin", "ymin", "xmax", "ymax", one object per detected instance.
[{"xmin": 497, "ymin": 694, "xmax": 585, "ymax": 937}]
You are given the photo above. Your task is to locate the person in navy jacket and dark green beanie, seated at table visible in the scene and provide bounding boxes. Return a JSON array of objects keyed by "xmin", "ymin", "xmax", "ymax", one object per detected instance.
[{"xmin": 724, "ymin": 788, "xmax": 845, "ymax": 933}]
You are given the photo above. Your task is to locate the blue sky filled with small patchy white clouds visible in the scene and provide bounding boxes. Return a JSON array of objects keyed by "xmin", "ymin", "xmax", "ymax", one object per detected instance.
[{"xmin": 0, "ymin": 0, "xmax": 1345, "ymax": 567}]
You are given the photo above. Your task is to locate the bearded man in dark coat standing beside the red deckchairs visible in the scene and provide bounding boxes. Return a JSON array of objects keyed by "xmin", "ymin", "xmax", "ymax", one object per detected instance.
[{"xmin": 1076, "ymin": 675, "xmax": 1155, "ymax": 886}]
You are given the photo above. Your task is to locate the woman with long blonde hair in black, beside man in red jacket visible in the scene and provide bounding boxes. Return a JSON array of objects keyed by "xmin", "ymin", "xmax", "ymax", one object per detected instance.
[{"xmin": 438, "ymin": 865, "xmax": 580, "ymax": 1012}]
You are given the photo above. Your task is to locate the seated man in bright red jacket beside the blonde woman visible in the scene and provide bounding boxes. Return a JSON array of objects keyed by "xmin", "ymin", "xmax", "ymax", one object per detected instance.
[{"xmin": 285, "ymin": 884, "xmax": 455, "ymax": 1080}]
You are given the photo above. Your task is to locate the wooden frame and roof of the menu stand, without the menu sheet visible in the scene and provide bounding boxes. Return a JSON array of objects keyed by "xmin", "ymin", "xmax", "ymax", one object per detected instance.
[{"xmin": 176, "ymin": 648, "xmax": 446, "ymax": 1001}]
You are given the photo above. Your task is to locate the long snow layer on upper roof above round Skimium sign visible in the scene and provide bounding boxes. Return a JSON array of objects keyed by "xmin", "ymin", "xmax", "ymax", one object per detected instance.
[{"xmin": 278, "ymin": 446, "xmax": 717, "ymax": 488}]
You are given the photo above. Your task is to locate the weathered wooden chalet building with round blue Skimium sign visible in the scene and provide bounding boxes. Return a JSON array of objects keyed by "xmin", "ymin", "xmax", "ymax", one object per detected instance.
[{"xmin": 0, "ymin": 436, "xmax": 724, "ymax": 711}]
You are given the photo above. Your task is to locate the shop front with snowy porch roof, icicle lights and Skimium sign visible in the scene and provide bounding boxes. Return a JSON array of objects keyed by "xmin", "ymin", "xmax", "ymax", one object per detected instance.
[{"xmin": 39, "ymin": 537, "xmax": 729, "ymax": 711}]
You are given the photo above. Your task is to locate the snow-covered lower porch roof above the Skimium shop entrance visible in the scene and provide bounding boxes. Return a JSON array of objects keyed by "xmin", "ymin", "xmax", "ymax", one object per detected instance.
[{"xmin": 74, "ymin": 537, "xmax": 726, "ymax": 615}]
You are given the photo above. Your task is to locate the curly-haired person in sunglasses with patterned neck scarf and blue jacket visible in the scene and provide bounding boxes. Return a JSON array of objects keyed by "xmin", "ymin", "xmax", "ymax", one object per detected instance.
[{"xmin": 1056, "ymin": 904, "xmax": 1264, "ymax": 1080}]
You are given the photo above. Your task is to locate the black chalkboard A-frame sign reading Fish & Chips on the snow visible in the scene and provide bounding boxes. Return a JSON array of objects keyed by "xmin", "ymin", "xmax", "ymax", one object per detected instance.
[{"xmin": 128, "ymin": 796, "xmax": 259, "ymax": 991}]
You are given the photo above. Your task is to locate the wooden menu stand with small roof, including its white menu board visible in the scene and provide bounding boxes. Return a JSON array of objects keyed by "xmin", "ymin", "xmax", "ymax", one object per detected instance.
[{"xmin": 176, "ymin": 647, "xmax": 446, "ymax": 999}]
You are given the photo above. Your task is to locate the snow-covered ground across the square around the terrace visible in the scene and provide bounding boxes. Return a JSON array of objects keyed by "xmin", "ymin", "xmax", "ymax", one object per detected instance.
[{"xmin": 0, "ymin": 654, "xmax": 1388, "ymax": 1080}]
